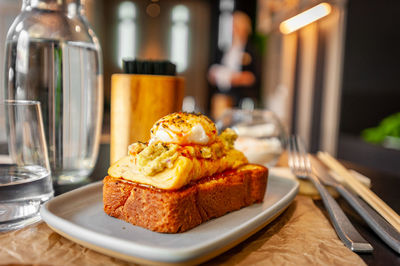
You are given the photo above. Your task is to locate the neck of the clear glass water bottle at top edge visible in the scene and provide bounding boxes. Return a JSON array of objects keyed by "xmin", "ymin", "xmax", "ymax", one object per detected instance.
[{"xmin": 22, "ymin": 0, "xmax": 81, "ymax": 14}]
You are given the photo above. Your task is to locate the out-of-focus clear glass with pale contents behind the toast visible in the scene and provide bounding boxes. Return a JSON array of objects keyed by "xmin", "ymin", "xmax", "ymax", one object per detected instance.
[{"xmin": 216, "ymin": 109, "xmax": 286, "ymax": 167}]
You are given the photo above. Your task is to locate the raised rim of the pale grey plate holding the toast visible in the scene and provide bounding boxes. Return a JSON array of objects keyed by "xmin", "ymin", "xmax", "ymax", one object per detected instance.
[{"xmin": 40, "ymin": 174, "xmax": 299, "ymax": 264}]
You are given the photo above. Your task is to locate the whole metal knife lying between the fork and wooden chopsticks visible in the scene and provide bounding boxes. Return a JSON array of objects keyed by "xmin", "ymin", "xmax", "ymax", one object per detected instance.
[{"xmin": 310, "ymin": 156, "xmax": 400, "ymax": 254}]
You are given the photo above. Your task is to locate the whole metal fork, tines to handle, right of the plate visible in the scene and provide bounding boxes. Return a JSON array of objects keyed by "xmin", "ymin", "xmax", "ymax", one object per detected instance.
[{"xmin": 288, "ymin": 136, "xmax": 373, "ymax": 253}]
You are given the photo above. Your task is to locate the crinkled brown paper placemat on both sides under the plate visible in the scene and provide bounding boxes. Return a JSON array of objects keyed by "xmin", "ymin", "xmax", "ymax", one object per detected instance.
[{"xmin": 0, "ymin": 196, "xmax": 365, "ymax": 266}]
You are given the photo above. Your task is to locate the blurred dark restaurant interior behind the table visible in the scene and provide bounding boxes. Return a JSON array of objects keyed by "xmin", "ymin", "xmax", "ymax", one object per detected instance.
[{"xmin": 0, "ymin": 0, "xmax": 400, "ymax": 173}]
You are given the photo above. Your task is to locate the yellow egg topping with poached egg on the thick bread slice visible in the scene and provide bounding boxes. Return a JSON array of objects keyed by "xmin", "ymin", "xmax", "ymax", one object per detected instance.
[{"xmin": 108, "ymin": 113, "xmax": 247, "ymax": 189}]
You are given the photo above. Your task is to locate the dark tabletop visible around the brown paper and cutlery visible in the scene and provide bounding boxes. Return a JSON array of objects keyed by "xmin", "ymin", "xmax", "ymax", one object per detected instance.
[{"xmin": 55, "ymin": 144, "xmax": 400, "ymax": 265}]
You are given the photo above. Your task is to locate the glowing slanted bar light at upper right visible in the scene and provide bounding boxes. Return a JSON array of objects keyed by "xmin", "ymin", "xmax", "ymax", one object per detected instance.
[{"xmin": 279, "ymin": 3, "xmax": 332, "ymax": 34}]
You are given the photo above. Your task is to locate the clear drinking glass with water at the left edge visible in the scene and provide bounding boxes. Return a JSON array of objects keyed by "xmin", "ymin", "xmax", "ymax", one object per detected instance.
[{"xmin": 0, "ymin": 100, "xmax": 53, "ymax": 231}]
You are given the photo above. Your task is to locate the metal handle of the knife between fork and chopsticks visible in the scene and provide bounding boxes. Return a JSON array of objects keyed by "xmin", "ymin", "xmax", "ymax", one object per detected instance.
[{"xmin": 336, "ymin": 185, "xmax": 400, "ymax": 254}]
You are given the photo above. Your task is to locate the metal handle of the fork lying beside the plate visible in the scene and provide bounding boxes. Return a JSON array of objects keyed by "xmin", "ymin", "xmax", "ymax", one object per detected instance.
[{"xmin": 309, "ymin": 174, "xmax": 373, "ymax": 253}]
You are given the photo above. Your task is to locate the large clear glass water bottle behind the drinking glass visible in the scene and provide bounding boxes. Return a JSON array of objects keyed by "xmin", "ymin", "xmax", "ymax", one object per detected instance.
[{"xmin": 4, "ymin": 0, "xmax": 103, "ymax": 184}]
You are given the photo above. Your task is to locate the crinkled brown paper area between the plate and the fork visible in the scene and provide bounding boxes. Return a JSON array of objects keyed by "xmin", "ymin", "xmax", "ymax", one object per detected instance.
[{"xmin": 206, "ymin": 196, "xmax": 365, "ymax": 266}]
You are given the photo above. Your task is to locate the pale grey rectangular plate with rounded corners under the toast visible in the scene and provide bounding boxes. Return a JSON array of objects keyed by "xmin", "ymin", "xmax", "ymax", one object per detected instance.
[{"xmin": 40, "ymin": 174, "xmax": 299, "ymax": 265}]
